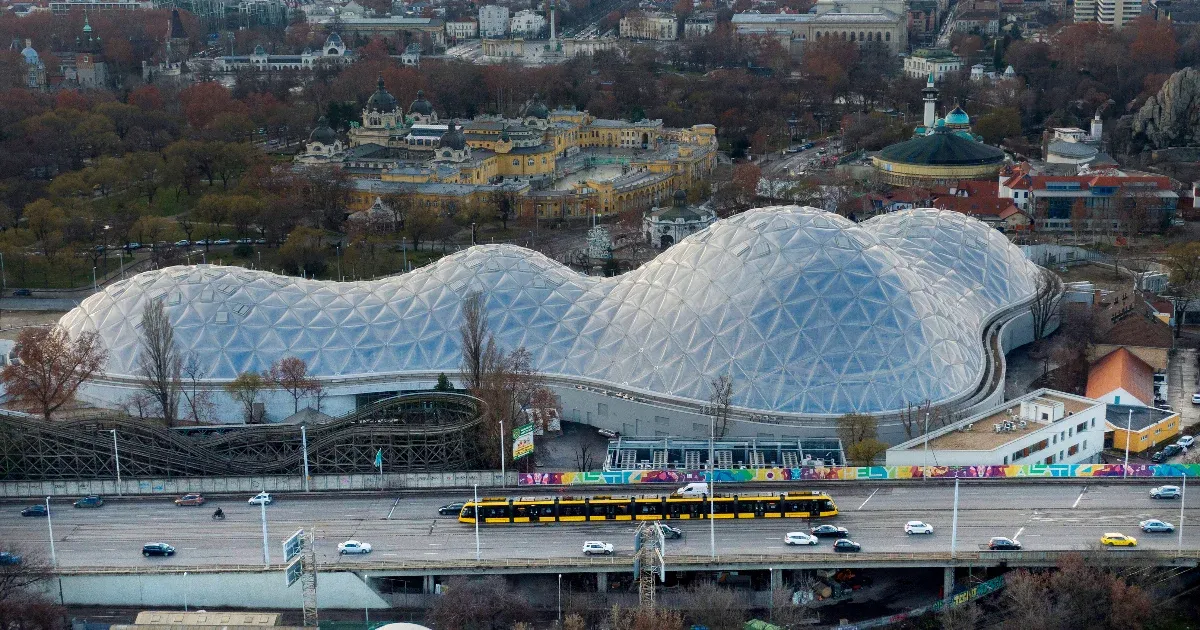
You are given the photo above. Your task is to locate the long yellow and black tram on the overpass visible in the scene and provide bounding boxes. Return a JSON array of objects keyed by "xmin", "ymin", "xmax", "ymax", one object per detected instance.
[{"xmin": 458, "ymin": 492, "xmax": 838, "ymax": 524}]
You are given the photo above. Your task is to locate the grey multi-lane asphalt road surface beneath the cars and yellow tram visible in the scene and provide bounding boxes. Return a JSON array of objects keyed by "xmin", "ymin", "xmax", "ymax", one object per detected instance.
[{"xmin": 0, "ymin": 481, "xmax": 1200, "ymax": 568}]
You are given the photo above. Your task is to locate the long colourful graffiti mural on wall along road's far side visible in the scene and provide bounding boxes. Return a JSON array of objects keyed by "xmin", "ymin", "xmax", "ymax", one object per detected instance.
[{"xmin": 518, "ymin": 463, "xmax": 1200, "ymax": 486}]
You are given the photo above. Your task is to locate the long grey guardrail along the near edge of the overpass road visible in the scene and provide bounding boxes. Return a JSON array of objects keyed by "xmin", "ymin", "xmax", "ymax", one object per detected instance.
[{"xmin": 56, "ymin": 550, "xmax": 1200, "ymax": 576}]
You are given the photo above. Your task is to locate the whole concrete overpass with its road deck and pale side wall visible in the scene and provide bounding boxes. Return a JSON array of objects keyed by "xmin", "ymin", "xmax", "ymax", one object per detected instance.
[{"xmin": 0, "ymin": 480, "xmax": 1200, "ymax": 608}]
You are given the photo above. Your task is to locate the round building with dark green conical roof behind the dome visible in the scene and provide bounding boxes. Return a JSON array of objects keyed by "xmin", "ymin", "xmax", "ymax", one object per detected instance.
[{"xmin": 872, "ymin": 120, "xmax": 1004, "ymax": 186}]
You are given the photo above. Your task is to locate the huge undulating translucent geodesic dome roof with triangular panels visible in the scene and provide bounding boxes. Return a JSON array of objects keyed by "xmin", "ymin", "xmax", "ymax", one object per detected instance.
[{"xmin": 61, "ymin": 206, "xmax": 1036, "ymax": 414}]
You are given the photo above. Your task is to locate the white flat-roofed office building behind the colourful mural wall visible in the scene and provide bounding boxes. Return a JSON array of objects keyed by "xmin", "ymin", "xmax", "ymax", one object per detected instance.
[{"xmin": 886, "ymin": 389, "xmax": 1108, "ymax": 466}]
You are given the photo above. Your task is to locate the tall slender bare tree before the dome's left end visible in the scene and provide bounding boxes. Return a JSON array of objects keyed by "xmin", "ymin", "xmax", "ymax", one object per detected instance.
[{"xmin": 138, "ymin": 300, "xmax": 182, "ymax": 426}]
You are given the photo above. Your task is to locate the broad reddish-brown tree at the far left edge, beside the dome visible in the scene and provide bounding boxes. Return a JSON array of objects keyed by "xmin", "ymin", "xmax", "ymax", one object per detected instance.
[{"xmin": 0, "ymin": 326, "xmax": 108, "ymax": 421}]
